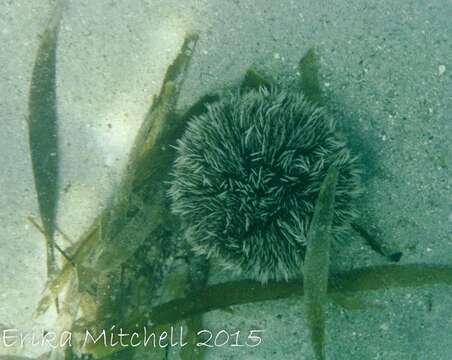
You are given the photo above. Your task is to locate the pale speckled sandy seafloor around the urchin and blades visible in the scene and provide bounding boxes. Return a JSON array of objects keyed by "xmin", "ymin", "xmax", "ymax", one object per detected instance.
[{"xmin": 0, "ymin": 0, "xmax": 452, "ymax": 360}]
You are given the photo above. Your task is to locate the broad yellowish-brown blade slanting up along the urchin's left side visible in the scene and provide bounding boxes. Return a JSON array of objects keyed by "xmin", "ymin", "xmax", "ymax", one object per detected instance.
[{"xmin": 90, "ymin": 34, "xmax": 197, "ymax": 272}]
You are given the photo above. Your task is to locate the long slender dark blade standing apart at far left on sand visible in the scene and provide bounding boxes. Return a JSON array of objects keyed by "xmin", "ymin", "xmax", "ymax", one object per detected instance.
[{"xmin": 27, "ymin": 3, "xmax": 63, "ymax": 275}]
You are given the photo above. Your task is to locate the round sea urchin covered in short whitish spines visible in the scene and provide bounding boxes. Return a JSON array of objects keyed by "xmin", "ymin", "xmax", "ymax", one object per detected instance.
[{"xmin": 170, "ymin": 86, "xmax": 360, "ymax": 282}]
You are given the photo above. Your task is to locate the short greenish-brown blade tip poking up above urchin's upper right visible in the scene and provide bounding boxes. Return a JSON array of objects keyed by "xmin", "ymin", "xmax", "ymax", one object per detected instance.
[{"xmin": 298, "ymin": 48, "xmax": 322, "ymax": 105}]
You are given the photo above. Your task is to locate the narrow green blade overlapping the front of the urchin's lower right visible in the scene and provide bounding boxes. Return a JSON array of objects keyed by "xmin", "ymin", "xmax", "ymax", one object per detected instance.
[{"xmin": 303, "ymin": 167, "xmax": 337, "ymax": 359}]
